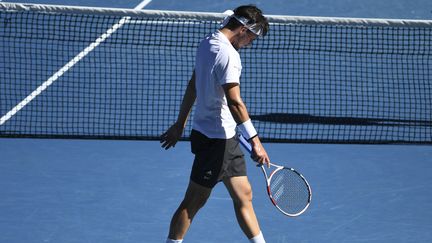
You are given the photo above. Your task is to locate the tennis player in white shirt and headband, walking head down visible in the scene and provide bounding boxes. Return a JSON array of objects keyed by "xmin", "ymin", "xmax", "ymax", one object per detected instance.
[{"xmin": 160, "ymin": 5, "xmax": 270, "ymax": 243}]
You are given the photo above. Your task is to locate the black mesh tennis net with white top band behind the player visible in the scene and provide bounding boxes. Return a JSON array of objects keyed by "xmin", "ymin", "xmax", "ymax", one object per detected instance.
[{"xmin": 0, "ymin": 3, "xmax": 432, "ymax": 144}]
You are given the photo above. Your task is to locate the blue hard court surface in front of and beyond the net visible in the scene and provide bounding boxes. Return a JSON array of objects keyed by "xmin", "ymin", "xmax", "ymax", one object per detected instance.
[{"xmin": 0, "ymin": 0, "xmax": 432, "ymax": 243}]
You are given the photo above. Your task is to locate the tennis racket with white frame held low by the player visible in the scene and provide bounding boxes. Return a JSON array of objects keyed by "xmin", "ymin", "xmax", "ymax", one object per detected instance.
[{"xmin": 239, "ymin": 135, "xmax": 312, "ymax": 217}]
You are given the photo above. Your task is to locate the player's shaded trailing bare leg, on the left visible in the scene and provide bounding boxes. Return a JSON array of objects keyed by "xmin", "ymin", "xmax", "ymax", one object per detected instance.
[{"xmin": 168, "ymin": 181, "xmax": 212, "ymax": 240}]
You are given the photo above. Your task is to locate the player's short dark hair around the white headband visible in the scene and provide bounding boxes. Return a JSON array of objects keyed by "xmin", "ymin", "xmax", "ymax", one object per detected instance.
[{"xmin": 225, "ymin": 5, "xmax": 269, "ymax": 36}]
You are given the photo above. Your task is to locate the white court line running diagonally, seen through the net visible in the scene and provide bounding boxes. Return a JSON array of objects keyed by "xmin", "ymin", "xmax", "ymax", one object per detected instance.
[{"xmin": 0, "ymin": 0, "xmax": 151, "ymax": 126}]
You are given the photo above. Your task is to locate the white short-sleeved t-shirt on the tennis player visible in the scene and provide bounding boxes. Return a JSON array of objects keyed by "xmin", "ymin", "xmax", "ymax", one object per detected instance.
[{"xmin": 192, "ymin": 31, "xmax": 242, "ymax": 139}]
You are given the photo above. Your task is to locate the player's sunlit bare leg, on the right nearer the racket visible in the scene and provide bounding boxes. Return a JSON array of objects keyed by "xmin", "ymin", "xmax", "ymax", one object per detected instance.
[{"xmin": 223, "ymin": 176, "xmax": 261, "ymax": 239}]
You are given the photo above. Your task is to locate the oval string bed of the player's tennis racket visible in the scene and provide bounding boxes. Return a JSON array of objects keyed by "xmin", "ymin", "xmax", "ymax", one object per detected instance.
[{"xmin": 270, "ymin": 168, "xmax": 310, "ymax": 214}]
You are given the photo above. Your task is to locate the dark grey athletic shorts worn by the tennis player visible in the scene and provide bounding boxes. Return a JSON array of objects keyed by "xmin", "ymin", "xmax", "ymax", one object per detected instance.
[{"xmin": 190, "ymin": 130, "xmax": 246, "ymax": 188}]
